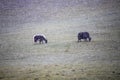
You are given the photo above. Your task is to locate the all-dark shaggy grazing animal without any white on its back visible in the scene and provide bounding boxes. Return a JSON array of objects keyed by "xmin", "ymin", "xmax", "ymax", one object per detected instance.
[{"xmin": 78, "ymin": 32, "xmax": 91, "ymax": 42}]
